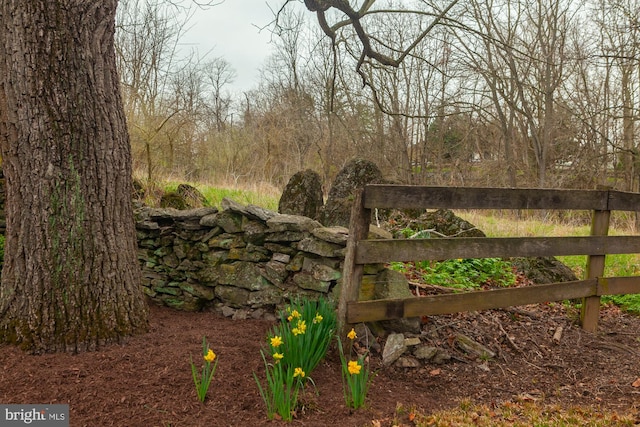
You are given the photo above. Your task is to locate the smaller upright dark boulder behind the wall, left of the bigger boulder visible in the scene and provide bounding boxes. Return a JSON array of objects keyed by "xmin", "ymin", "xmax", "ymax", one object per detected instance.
[{"xmin": 278, "ymin": 169, "xmax": 323, "ymax": 219}]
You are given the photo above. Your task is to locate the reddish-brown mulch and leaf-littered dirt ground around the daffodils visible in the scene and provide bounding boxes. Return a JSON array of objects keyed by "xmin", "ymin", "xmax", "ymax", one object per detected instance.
[{"xmin": 0, "ymin": 304, "xmax": 640, "ymax": 427}]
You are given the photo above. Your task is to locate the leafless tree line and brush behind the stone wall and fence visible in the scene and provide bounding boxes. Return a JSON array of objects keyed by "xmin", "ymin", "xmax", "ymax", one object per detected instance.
[{"xmin": 116, "ymin": 0, "xmax": 640, "ymax": 191}]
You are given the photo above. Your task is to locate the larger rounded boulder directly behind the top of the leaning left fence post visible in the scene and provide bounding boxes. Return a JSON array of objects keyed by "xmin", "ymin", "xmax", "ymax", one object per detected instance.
[{"xmin": 320, "ymin": 158, "xmax": 383, "ymax": 227}]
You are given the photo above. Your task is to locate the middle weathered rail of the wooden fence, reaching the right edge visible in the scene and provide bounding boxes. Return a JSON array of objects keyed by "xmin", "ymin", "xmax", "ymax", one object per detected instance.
[{"xmin": 355, "ymin": 236, "xmax": 640, "ymax": 264}]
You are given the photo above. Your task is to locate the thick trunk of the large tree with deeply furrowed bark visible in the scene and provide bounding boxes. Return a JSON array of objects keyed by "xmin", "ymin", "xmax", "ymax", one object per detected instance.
[{"xmin": 0, "ymin": 0, "xmax": 147, "ymax": 353}]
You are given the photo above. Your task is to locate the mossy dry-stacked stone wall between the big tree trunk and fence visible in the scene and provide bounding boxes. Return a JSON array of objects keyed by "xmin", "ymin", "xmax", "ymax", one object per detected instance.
[{"xmin": 136, "ymin": 199, "xmax": 390, "ymax": 317}]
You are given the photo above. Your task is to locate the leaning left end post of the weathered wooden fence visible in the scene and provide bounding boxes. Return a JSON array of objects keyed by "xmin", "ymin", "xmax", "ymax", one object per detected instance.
[{"xmin": 338, "ymin": 189, "xmax": 371, "ymax": 339}]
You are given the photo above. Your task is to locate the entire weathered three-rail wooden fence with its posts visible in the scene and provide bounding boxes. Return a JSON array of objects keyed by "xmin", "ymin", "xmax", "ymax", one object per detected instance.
[{"xmin": 338, "ymin": 185, "xmax": 640, "ymax": 332}]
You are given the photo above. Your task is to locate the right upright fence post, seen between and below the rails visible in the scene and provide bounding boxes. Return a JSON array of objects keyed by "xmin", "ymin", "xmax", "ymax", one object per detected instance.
[{"xmin": 580, "ymin": 206, "xmax": 611, "ymax": 332}]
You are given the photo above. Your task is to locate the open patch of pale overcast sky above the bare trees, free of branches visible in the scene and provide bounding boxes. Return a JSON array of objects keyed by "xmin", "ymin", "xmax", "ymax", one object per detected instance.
[{"xmin": 182, "ymin": 0, "xmax": 284, "ymax": 92}]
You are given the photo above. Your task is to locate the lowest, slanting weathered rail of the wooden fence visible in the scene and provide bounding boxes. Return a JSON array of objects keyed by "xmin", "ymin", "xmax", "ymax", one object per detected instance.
[{"xmin": 347, "ymin": 279, "xmax": 598, "ymax": 323}]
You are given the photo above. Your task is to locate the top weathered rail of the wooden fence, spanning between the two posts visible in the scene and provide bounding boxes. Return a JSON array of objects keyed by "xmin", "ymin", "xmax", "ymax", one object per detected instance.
[{"xmin": 364, "ymin": 184, "xmax": 608, "ymax": 210}]
